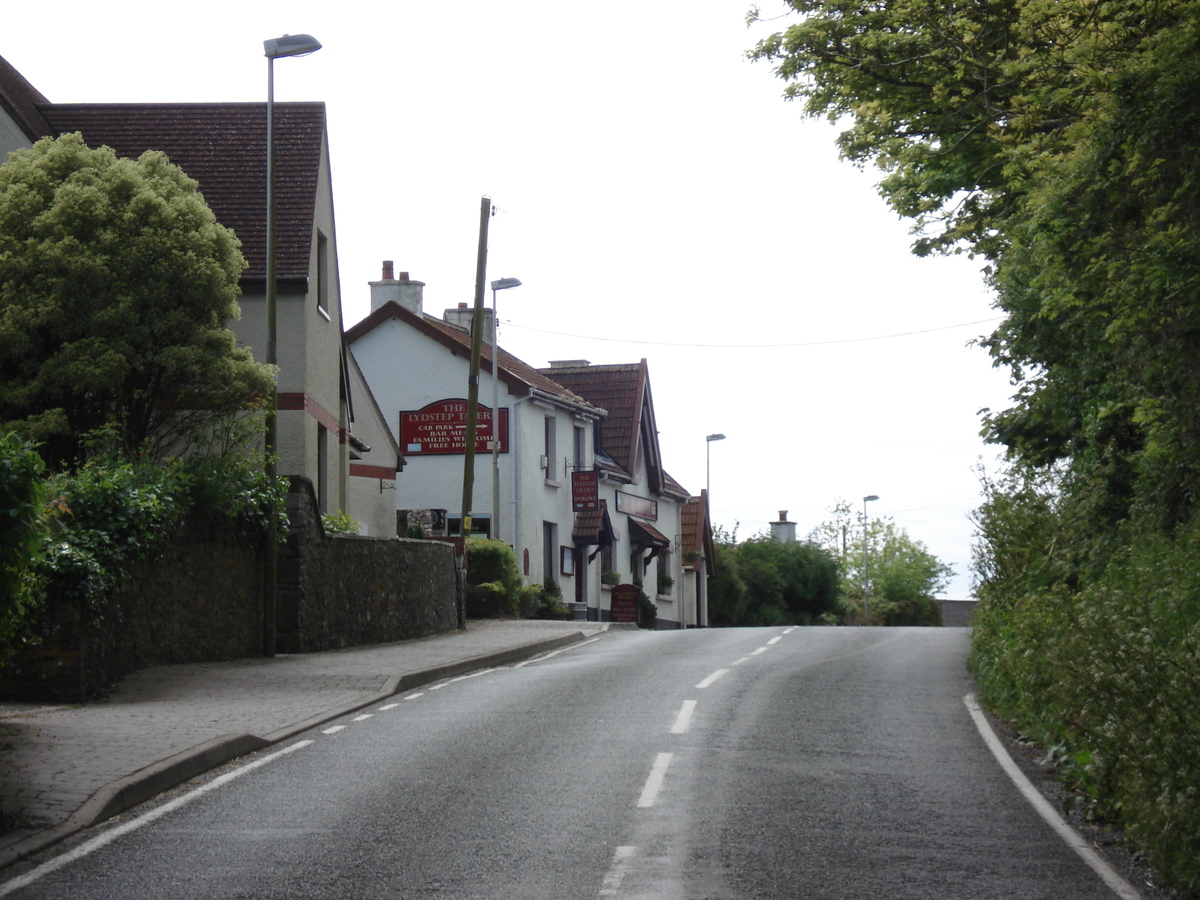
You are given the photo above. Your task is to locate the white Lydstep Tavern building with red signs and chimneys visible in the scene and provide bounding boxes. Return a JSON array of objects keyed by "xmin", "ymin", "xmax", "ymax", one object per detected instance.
[{"xmin": 347, "ymin": 263, "xmax": 712, "ymax": 628}]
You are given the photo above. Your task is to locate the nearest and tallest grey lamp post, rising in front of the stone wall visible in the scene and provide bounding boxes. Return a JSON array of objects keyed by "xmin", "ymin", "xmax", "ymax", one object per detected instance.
[{"xmin": 263, "ymin": 35, "xmax": 320, "ymax": 656}]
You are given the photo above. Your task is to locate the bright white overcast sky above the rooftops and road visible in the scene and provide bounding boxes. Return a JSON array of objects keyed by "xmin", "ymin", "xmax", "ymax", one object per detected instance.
[{"xmin": 0, "ymin": 0, "xmax": 1012, "ymax": 599}]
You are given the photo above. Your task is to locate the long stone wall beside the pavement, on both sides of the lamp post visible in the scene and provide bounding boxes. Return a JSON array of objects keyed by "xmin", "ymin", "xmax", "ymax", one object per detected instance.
[{"xmin": 0, "ymin": 479, "xmax": 457, "ymax": 703}]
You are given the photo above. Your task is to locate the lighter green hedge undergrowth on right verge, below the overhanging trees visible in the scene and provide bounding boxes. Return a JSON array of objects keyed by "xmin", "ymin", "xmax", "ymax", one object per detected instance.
[{"xmin": 970, "ymin": 480, "xmax": 1200, "ymax": 896}]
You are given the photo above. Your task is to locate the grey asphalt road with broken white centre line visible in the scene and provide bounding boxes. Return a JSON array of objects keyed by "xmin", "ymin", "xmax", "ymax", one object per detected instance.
[{"xmin": 0, "ymin": 629, "xmax": 1128, "ymax": 900}]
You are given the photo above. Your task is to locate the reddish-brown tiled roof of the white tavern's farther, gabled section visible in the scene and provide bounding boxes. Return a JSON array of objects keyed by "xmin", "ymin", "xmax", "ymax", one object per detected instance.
[{"xmin": 540, "ymin": 360, "xmax": 649, "ymax": 474}]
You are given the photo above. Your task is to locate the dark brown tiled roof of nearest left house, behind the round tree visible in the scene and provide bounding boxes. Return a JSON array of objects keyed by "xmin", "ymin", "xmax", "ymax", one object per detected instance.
[{"xmin": 38, "ymin": 98, "xmax": 325, "ymax": 280}]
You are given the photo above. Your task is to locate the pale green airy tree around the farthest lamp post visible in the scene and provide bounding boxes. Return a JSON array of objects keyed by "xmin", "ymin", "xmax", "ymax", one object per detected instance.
[{"xmin": 810, "ymin": 500, "xmax": 954, "ymax": 625}]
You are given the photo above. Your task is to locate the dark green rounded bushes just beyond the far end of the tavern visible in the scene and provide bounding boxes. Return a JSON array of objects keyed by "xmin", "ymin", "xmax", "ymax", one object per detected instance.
[{"xmin": 708, "ymin": 529, "xmax": 838, "ymax": 626}]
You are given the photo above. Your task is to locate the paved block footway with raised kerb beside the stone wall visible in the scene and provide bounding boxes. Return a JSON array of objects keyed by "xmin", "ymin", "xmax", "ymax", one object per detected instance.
[{"xmin": 0, "ymin": 619, "xmax": 610, "ymax": 869}]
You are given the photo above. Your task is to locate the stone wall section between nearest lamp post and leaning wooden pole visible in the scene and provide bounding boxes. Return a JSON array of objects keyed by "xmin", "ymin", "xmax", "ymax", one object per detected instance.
[{"xmin": 276, "ymin": 479, "xmax": 458, "ymax": 653}]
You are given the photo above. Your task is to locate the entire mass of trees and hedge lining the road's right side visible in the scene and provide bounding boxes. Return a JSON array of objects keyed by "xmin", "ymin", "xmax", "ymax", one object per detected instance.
[{"xmin": 751, "ymin": 0, "xmax": 1200, "ymax": 896}]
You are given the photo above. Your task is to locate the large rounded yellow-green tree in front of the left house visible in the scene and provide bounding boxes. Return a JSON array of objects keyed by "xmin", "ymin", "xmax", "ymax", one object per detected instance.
[{"xmin": 0, "ymin": 134, "xmax": 271, "ymax": 466}]
